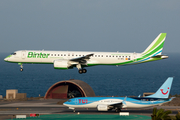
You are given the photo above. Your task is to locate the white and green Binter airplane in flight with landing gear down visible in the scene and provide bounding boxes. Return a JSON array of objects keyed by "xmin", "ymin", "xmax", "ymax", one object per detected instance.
[{"xmin": 4, "ymin": 33, "xmax": 168, "ymax": 74}]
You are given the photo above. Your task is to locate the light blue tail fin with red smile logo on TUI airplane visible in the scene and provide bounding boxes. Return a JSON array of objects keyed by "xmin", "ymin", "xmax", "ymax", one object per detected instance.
[{"xmin": 146, "ymin": 77, "xmax": 173, "ymax": 98}]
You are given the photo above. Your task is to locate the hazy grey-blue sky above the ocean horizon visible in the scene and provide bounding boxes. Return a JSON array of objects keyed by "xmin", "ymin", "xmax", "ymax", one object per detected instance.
[{"xmin": 0, "ymin": 0, "xmax": 180, "ymax": 53}]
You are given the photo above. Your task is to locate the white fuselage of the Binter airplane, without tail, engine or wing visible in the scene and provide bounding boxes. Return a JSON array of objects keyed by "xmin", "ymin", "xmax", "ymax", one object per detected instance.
[{"xmin": 5, "ymin": 50, "xmax": 140, "ymax": 66}]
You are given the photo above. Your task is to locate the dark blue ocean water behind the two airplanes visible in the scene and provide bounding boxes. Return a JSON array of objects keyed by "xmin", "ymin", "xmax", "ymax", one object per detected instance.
[{"xmin": 0, "ymin": 53, "xmax": 180, "ymax": 97}]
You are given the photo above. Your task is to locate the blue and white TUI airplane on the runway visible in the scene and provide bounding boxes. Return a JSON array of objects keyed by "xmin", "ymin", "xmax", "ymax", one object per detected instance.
[{"xmin": 63, "ymin": 77, "xmax": 173, "ymax": 112}]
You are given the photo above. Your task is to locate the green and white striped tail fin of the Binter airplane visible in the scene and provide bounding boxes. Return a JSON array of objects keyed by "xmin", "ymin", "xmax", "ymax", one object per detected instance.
[{"xmin": 142, "ymin": 33, "xmax": 166, "ymax": 57}]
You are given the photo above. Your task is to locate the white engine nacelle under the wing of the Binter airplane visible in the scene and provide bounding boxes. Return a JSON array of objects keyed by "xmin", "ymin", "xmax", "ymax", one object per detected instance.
[{"xmin": 54, "ymin": 60, "xmax": 69, "ymax": 69}]
